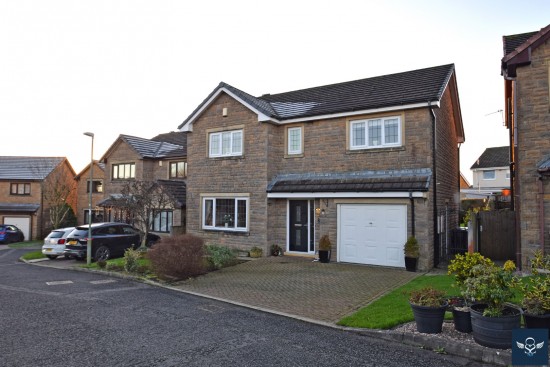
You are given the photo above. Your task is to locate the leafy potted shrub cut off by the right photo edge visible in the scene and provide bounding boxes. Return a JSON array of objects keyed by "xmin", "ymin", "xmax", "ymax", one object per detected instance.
[{"xmin": 521, "ymin": 250, "xmax": 550, "ymax": 336}]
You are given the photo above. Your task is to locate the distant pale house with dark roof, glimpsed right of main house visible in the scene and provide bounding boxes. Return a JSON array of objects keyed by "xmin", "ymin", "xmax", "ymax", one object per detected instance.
[{"xmin": 461, "ymin": 146, "xmax": 511, "ymax": 209}]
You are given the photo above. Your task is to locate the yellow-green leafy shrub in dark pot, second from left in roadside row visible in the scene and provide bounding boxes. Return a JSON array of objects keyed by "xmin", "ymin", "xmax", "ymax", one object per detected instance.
[{"xmin": 447, "ymin": 252, "xmax": 492, "ymax": 333}]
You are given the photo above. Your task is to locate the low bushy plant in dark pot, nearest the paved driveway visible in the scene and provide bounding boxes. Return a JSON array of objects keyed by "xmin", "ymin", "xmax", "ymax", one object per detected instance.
[{"xmin": 409, "ymin": 287, "xmax": 448, "ymax": 334}]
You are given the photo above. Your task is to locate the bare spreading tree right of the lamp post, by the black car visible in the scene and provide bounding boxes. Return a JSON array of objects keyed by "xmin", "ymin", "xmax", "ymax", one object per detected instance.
[{"xmin": 119, "ymin": 180, "xmax": 173, "ymax": 248}]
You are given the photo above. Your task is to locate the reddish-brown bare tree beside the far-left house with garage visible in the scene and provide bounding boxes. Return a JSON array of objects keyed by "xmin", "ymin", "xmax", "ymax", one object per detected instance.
[{"xmin": 38, "ymin": 161, "xmax": 76, "ymax": 228}]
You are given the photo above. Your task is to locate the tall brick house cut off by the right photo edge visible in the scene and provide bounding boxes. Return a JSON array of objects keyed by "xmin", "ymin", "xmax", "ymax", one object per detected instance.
[{"xmin": 501, "ymin": 25, "xmax": 550, "ymax": 266}]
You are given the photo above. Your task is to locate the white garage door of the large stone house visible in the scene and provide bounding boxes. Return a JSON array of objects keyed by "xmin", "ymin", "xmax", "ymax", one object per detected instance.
[{"xmin": 338, "ymin": 204, "xmax": 407, "ymax": 267}]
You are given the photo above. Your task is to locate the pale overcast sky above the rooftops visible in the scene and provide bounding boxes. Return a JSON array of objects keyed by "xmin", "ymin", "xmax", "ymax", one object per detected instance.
[{"xmin": 0, "ymin": 0, "xmax": 550, "ymax": 182}]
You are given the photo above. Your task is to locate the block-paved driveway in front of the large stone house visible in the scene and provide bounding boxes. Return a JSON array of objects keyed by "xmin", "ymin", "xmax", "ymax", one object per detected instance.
[{"xmin": 174, "ymin": 256, "xmax": 420, "ymax": 323}]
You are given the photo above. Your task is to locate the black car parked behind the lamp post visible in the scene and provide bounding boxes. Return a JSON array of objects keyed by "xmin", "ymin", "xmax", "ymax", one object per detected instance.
[{"xmin": 64, "ymin": 222, "xmax": 160, "ymax": 261}]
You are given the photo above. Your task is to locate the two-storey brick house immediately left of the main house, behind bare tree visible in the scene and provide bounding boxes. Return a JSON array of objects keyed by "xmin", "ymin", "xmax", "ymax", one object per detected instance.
[{"xmin": 97, "ymin": 132, "xmax": 187, "ymax": 234}]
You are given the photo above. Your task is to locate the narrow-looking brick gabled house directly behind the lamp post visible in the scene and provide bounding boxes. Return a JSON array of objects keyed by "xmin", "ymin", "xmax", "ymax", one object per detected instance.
[{"xmin": 75, "ymin": 160, "xmax": 105, "ymax": 224}]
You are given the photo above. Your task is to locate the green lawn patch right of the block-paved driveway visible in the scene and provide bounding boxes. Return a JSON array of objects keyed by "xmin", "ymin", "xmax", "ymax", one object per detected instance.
[{"xmin": 338, "ymin": 275, "xmax": 460, "ymax": 329}]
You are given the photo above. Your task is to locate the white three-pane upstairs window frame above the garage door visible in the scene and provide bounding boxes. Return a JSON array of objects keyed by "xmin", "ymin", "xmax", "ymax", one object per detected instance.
[{"xmin": 349, "ymin": 116, "xmax": 403, "ymax": 150}]
